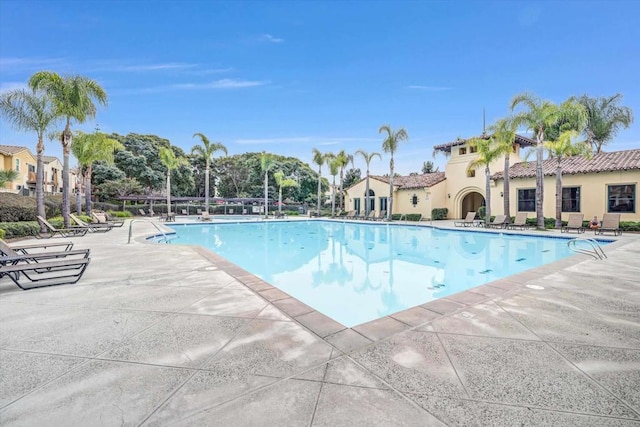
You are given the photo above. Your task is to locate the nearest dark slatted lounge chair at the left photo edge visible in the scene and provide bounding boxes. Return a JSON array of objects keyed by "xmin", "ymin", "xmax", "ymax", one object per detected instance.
[{"xmin": 0, "ymin": 246, "xmax": 91, "ymax": 290}]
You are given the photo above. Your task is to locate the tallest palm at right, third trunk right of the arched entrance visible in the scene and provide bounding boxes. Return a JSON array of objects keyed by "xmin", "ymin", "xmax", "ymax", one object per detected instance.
[{"xmin": 511, "ymin": 93, "xmax": 585, "ymax": 230}]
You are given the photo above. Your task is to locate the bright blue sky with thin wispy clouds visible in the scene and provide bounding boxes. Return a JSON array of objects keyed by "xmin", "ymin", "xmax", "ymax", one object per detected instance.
[{"xmin": 0, "ymin": 0, "xmax": 640, "ymax": 176}]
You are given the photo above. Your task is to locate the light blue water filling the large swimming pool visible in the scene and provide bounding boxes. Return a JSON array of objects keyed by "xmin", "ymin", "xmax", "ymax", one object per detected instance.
[{"xmin": 160, "ymin": 221, "xmax": 604, "ymax": 327}]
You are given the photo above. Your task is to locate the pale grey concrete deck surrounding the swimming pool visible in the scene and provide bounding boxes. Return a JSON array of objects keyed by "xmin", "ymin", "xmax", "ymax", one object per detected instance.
[{"xmin": 0, "ymin": 221, "xmax": 640, "ymax": 426}]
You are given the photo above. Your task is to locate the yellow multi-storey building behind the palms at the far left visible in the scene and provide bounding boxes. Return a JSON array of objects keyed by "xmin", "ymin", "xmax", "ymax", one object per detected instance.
[{"xmin": 0, "ymin": 145, "xmax": 76, "ymax": 196}]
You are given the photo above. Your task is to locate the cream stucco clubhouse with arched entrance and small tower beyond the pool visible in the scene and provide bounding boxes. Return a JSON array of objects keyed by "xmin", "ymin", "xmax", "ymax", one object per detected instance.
[{"xmin": 345, "ymin": 135, "xmax": 640, "ymax": 221}]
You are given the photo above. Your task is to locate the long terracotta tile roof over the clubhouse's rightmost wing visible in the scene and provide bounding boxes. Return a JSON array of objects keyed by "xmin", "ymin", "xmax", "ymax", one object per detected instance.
[{"xmin": 491, "ymin": 149, "xmax": 640, "ymax": 179}]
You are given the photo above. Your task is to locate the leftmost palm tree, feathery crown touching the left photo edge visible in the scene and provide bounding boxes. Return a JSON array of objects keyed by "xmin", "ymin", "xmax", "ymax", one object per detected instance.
[{"xmin": 0, "ymin": 89, "xmax": 57, "ymax": 226}]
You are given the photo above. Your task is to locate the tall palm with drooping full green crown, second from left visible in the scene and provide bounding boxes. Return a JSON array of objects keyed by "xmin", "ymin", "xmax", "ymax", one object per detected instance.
[{"xmin": 29, "ymin": 71, "xmax": 107, "ymax": 227}]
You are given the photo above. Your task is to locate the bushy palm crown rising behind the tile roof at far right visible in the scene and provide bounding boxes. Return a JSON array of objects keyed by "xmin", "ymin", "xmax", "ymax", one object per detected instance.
[{"xmin": 578, "ymin": 93, "xmax": 633, "ymax": 153}]
